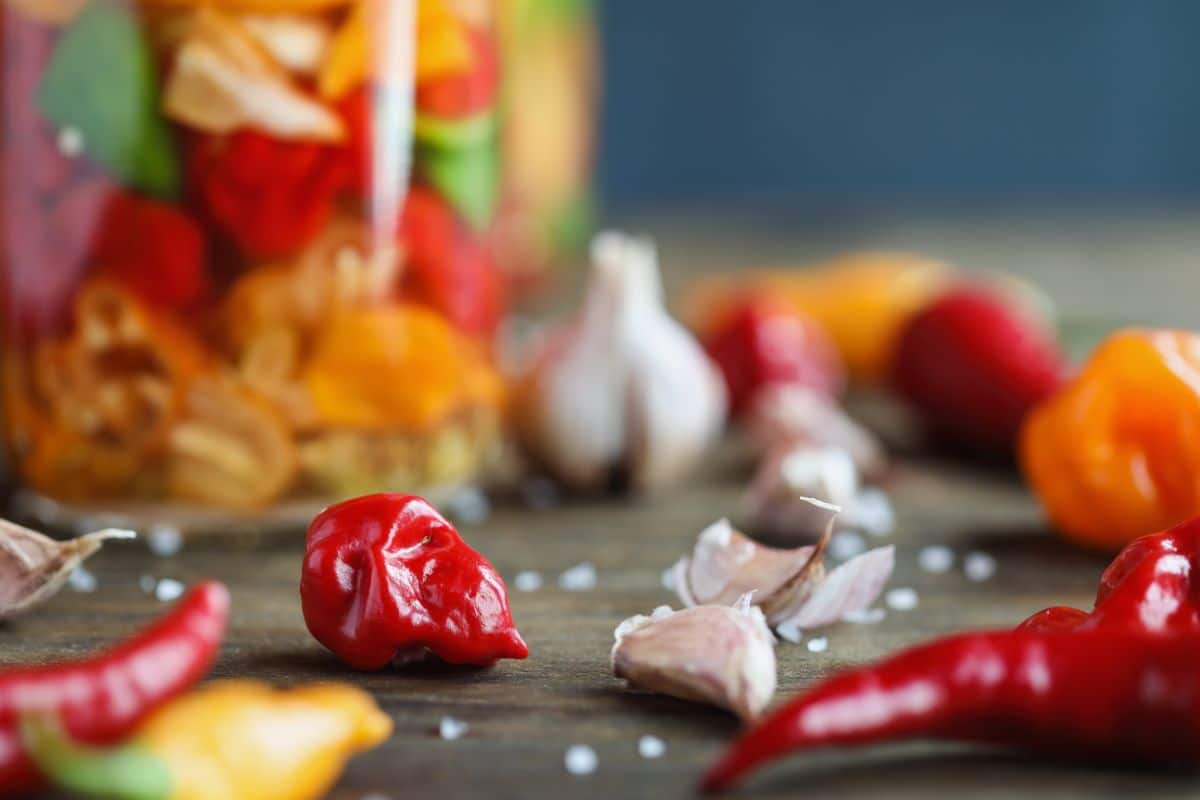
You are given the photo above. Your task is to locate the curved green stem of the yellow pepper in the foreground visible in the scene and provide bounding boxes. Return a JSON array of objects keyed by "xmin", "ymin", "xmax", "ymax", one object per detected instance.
[{"xmin": 20, "ymin": 714, "xmax": 170, "ymax": 800}]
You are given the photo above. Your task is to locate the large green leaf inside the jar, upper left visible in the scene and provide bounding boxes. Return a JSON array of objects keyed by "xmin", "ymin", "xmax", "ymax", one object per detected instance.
[{"xmin": 37, "ymin": 1, "xmax": 180, "ymax": 198}]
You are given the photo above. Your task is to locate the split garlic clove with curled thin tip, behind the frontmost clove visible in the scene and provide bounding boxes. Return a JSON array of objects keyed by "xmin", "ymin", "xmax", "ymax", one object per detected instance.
[{"xmin": 673, "ymin": 510, "xmax": 895, "ymax": 628}]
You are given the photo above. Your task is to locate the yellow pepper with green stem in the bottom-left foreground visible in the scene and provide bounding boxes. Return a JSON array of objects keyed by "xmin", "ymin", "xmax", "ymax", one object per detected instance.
[{"xmin": 22, "ymin": 680, "xmax": 392, "ymax": 800}]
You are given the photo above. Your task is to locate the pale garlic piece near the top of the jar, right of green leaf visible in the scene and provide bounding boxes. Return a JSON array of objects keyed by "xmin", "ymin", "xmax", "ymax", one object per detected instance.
[{"xmin": 163, "ymin": 6, "xmax": 346, "ymax": 142}]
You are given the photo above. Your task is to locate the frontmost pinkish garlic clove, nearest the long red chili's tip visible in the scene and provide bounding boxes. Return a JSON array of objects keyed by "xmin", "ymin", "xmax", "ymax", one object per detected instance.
[{"xmin": 612, "ymin": 595, "xmax": 775, "ymax": 720}]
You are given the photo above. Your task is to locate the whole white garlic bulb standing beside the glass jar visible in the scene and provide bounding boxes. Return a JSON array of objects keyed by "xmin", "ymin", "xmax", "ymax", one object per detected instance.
[{"xmin": 516, "ymin": 233, "xmax": 726, "ymax": 491}]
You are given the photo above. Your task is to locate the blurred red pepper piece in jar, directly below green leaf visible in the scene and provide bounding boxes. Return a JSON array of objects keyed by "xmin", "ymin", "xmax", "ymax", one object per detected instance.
[{"xmin": 92, "ymin": 191, "xmax": 208, "ymax": 308}]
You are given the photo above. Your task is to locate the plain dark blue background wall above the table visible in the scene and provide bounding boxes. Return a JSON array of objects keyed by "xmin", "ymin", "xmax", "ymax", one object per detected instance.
[{"xmin": 599, "ymin": 0, "xmax": 1200, "ymax": 207}]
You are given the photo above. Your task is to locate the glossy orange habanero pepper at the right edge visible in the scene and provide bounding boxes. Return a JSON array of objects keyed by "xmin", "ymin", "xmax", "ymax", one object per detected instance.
[{"xmin": 1020, "ymin": 330, "xmax": 1200, "ymax": 551}]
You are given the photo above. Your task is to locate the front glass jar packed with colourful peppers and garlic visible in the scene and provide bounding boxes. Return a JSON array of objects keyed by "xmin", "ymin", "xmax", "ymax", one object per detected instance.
[{"xmin": 0, "ymin": 0, "xmax": 504, "ymax": 527}]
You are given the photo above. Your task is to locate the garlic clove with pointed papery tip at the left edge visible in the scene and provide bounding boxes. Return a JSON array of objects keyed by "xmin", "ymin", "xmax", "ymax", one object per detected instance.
[{"xmin": 0, "ymin": 519, "xmax": 137, "ymax": 619}]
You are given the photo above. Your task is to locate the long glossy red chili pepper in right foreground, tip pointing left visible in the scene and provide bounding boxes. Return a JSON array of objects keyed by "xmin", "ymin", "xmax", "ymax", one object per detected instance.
[{"xmin": 703, "ymin": 628, "xmax": 1200, "ymax": 790}]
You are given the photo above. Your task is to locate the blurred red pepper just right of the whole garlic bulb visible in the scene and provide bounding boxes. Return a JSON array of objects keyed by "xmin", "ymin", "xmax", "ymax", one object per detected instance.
[{"xmin": 703, "ymin": 300, "xmax": 846, "ymax": 415}]
